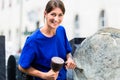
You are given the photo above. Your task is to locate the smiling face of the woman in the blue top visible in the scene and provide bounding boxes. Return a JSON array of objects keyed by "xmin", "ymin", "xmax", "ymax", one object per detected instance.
[{"xmin": 44, "ymin": 8, "xmax": 64, "ymax": 29}]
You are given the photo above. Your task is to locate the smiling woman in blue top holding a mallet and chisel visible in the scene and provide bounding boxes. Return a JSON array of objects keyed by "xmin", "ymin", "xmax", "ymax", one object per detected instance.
[{"xmin": 18, "ymin": 0, "xmax": 76, "ymax": 80}]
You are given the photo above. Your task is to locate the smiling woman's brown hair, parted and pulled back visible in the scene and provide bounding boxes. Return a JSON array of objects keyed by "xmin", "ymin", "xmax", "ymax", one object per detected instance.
[{"xmin": 45, "ymin": 0, "xmax": 65, "ymax": 14}]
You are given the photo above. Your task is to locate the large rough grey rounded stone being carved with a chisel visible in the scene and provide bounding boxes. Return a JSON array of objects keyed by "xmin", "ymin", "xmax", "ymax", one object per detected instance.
[{"xmin": 73, "ymin": 27, "xmax": 120, "ymax": 80}]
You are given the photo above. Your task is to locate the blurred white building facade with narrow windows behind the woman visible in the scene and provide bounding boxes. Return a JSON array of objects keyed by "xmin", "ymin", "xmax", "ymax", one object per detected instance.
[{"xmin": 0, "ymin": 0, "xmax": 120, "ymax": 79}]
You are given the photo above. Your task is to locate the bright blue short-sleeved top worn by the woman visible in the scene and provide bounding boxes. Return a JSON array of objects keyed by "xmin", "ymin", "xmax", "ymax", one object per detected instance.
[{"xmin": 19, "ymin": 26, "xmax": 72, "ymax": 80}]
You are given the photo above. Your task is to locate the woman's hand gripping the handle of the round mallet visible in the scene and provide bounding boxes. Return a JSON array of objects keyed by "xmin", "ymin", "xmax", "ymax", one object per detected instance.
[{"xmin": 43, "ymin": 69, "xmax": 59, "ymax": 80}]
